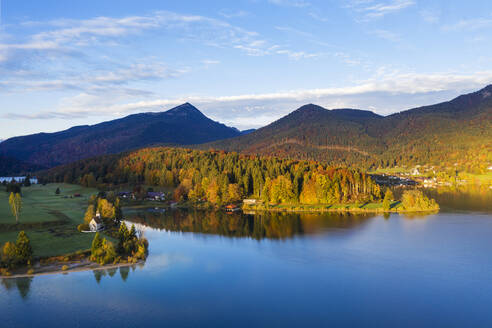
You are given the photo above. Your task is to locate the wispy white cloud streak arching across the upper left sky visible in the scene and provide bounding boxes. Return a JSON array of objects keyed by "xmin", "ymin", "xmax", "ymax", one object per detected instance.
[{"xmin": 0, "ymin": 11, "xmax": 320, "ymax": 76}]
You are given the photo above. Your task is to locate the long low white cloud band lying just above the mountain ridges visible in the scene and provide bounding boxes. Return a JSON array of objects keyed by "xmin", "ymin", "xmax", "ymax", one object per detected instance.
[{"xmin": 7, "ymin": 71, "xmax": 492, "ymax": 128}]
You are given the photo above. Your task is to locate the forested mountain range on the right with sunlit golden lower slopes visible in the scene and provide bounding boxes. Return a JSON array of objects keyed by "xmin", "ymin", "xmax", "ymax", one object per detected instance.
[{"xmin": 202, "ymin": 85, "xmax": 492, "ymax": 172}]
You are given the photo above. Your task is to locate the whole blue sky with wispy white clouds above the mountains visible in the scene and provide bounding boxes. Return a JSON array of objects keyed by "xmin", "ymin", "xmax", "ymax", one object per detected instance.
[{"xmin": 0, "ymin": 0, "xmax": 492, "ymax": 139}]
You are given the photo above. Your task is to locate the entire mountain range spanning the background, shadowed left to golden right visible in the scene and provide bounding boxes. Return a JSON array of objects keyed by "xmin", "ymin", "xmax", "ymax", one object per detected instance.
[{"xmin": 0, "ymin": 85, "xmax": 492, "ymax": 174}]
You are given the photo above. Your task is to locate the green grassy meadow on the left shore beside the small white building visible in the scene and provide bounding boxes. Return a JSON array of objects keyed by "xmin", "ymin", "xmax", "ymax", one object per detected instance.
[{"xmin": 0, "ymin": 184, "xmax": 97, "ymax": 257}]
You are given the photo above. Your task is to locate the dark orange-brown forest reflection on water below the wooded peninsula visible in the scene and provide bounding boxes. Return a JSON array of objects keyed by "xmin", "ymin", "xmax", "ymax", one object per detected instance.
[{"xmin": 125, "ymin": 209, "xmax": 374, "ymax": 240}]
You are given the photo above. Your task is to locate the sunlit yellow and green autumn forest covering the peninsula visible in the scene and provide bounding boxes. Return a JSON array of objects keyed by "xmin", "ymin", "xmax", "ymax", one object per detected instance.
[{"xmin": 38, "ymin": 147, "xmax": 382, "ymax": 205}]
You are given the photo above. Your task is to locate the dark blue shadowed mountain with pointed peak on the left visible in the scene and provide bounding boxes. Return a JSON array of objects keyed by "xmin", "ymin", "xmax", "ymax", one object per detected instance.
[{"xmin": 0, "ymin": 103, "xmax": 241, "ymax": 174}]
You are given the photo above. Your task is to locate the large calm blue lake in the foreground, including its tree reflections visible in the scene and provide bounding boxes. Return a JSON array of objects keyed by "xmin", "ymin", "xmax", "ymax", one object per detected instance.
[{"xmin": 0, "ymin": 193, "xmax": 492, "ymax": 327}]
